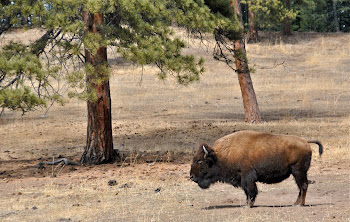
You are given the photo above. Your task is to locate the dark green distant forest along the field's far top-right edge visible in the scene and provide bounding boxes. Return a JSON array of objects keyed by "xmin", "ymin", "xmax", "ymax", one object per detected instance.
[{"xmin": 242, "ymin": 0, "xmax": 350, "ymax": 42}]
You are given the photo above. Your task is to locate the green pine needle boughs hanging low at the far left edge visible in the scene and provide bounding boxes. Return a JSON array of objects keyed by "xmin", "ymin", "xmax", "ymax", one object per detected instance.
[{"xmin": 0, "ymin": 43, "xmax": 63, "ymax": 114}]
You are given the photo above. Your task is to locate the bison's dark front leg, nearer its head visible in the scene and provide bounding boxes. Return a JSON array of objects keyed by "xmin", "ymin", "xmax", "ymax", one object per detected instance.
[{"xmin": 241, "ymin": 170, "xmax": 258, "ymax": 207}]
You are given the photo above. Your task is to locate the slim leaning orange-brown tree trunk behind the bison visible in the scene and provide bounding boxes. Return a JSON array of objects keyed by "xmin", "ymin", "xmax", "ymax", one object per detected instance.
[{"xmin": 232, "ymin": 0, "xmax": 261, "ymax": 123}]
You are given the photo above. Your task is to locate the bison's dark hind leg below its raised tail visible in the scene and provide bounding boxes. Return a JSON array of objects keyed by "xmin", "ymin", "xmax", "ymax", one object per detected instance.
[{"xmin": 292, "ymin": 155, "xmax": 311, "ymax": 206}]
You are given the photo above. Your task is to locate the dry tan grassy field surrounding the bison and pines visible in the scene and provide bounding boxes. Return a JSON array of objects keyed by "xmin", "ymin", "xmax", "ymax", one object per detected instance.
[{"xmin": 0, "ymin": 30, "xmax": 350, "ymax": 221}]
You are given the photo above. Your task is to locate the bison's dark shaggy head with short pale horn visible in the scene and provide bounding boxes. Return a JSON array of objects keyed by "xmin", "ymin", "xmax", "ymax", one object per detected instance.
[{"xmin": 190, "ymin": 144, "xmax": 218, "ymax": 189}]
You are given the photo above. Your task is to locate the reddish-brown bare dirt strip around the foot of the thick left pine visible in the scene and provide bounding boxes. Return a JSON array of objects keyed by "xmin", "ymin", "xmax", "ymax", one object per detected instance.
[{"xmin": 0, "ymin": 151, "xmax": 191, "ymax": 181}]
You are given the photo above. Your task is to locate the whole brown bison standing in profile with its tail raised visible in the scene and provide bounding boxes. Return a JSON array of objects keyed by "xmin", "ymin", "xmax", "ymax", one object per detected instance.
[{"xmin": 190, "ymin": 131, "xmax": 323, "ymax": 207}]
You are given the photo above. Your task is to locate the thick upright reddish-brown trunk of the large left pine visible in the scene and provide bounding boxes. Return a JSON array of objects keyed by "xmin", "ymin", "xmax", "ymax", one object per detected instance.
[{"xmin": 80, "ymin": 11, "xmax": 114, "ymax": 164}]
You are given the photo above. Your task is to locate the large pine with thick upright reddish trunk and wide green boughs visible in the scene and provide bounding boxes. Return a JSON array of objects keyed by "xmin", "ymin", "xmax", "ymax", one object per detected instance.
[{"xmin": 0, "ymin": 0, "xmax": 221, "ymax": 164}]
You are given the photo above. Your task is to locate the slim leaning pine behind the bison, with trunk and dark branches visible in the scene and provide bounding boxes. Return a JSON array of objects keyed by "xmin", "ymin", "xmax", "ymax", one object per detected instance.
[{"xmin": 206, "ymin": 0, "xmax": 261, "ymax": 123}]
